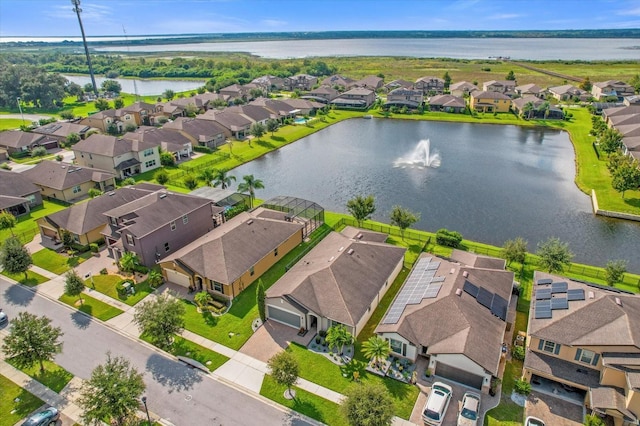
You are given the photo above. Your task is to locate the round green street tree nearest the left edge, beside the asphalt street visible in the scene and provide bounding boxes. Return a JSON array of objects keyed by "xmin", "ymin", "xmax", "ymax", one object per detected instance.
[{"xmin": 2, "ymin": 312, "xmax": 64, "ymax": 372}]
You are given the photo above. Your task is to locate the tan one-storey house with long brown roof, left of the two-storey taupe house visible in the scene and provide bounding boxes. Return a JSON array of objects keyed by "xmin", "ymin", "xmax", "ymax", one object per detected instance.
[{"xmin": 36, "ymin": 184, "xmax": 164, "ymax": 249}]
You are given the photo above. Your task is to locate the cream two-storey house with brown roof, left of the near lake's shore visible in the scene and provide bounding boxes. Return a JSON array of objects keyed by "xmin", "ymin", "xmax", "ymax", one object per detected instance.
[{"xmin": 73, "ymin": 134, "xmax": 160, "ymax": 179}]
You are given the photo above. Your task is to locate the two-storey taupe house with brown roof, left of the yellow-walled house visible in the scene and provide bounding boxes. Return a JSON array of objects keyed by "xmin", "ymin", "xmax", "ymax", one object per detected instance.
[{"xmin": 102, "ymin": 190, "xmax": 224, "ymax": 267}]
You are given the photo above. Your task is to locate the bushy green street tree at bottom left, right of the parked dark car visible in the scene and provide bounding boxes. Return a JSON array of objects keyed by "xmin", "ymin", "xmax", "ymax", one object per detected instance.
[{"xmin": 78, "ymin": 352, "xmax": 145, "ymax": 426}]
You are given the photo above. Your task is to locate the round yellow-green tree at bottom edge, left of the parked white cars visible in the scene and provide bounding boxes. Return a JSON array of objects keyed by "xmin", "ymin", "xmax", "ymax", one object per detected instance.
[{"xmin": 340, "ymin": 384, "xmax": 395, "ymax": 426}]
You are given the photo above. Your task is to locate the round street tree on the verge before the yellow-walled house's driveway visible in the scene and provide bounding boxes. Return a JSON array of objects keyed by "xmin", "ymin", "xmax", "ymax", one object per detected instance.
[{"xmin": 133, "ymin": 294, "xmax": 185, "ymax": 348}]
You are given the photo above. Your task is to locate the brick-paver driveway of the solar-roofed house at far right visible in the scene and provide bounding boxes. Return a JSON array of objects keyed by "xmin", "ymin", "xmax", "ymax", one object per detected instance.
[{"xmin": 525, "ymin": 391, "xmax": 584, "ymax": 426}]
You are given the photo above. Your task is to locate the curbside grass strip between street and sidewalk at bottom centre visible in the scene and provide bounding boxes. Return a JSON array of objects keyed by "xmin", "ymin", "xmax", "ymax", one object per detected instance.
[{"xmin": 260, "ymin": 375, "xmax": 348, "ymax": 426}]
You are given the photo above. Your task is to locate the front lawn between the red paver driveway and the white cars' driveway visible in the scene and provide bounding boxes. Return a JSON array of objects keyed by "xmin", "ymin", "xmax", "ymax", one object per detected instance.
[{"xmin": 287, "ymin": 343, "xmax": 420, "ymax": 420}]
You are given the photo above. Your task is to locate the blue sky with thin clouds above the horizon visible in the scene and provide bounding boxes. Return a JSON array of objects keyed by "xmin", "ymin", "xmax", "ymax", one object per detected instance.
[{"xmin": 0, "ymin": 0, "xmax": 640, "ymax": 37}]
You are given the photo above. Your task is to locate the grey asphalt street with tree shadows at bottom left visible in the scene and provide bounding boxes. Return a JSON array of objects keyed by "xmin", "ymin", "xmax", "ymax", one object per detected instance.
[{"xmin": 0, "ymin": 278, "xmax": 308, "ymax": 426}]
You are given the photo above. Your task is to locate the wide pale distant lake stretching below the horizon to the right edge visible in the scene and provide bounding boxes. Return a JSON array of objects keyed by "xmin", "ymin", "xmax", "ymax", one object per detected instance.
[{"xmin": 94, "ymin": 38, "xmax": 640, "ymax": 61}]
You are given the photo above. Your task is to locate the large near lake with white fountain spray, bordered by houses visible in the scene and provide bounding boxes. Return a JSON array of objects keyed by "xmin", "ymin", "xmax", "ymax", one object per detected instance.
[{"xmin": 232, "ymin": 119, "xmax": 640, "ymax": 272}]
